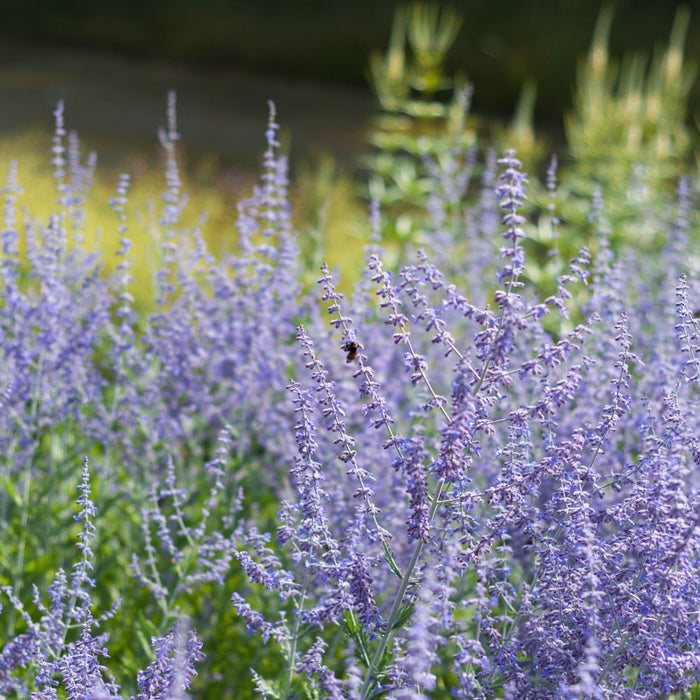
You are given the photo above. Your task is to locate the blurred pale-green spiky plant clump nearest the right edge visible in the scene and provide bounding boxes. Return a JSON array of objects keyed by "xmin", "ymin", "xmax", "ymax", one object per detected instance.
[{"xmin": 563, "ymin": 3, "xmax": 697, "ymax": 260}]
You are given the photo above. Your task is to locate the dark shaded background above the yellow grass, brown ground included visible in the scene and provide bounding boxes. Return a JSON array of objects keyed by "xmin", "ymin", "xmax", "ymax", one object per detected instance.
[{"xmin": 0, "ymin": 0, "xmax": 700, "ymax": 171}]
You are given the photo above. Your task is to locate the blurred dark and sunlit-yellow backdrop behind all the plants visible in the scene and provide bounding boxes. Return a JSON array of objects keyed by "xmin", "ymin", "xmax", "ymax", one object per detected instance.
[{"xmin": 0, "ymin": 0, "xmax": 700, "ymax": 298}]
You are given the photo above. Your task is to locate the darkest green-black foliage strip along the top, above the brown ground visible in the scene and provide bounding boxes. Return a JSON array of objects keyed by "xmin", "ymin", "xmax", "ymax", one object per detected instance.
[{"xmin": 5, "ymin": 0, "xmax": 700, "ymax": 119}]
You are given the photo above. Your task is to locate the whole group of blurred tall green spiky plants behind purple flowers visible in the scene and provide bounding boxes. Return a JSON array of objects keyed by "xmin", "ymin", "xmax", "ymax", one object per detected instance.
[{"xmin": 368, "ymin": 3, "xmax": 696, "ymax": 294}]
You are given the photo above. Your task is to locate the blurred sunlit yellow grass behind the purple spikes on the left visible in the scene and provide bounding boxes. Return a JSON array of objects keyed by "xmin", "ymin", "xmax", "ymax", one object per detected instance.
[{"xmin": 0, "ymin": 130, "xmax": 367, "ymax": 310}]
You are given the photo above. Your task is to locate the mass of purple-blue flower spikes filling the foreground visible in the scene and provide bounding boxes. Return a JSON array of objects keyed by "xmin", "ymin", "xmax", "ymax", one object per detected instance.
[{"xmin": 0, "ymin": 94, "xmax": 700, "ymax": 700}]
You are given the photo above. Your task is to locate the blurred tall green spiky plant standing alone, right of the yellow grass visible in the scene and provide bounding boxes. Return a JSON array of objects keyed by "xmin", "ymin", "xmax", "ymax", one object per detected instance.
[{"xmin": 367, "ymin": 3, "xmax": 476, "ymax": 262}]
